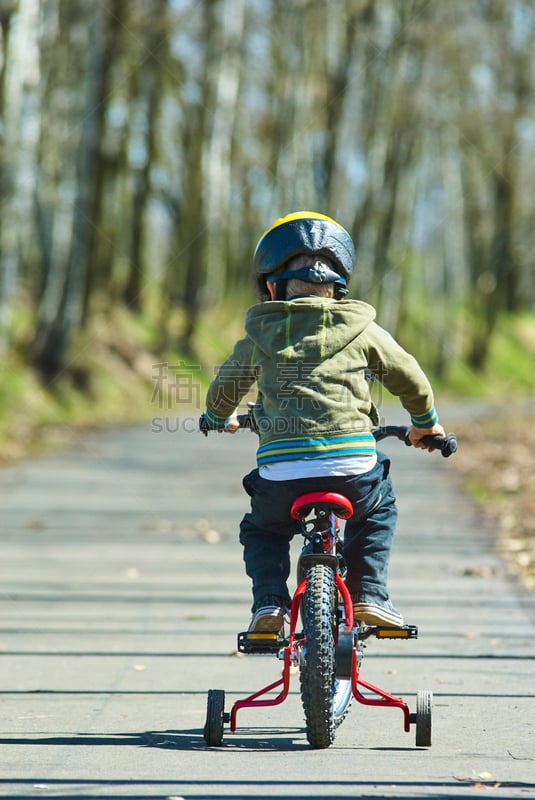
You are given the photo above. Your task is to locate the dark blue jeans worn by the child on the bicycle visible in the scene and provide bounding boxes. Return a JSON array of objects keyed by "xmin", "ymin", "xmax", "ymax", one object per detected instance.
[{"xmin": 240, "ymin": 453, "xmax": 397, "ymax": 609}]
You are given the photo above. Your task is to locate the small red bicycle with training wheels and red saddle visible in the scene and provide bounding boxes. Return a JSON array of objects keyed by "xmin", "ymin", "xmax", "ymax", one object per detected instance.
[{"xmin": 200, "ymin": 404, "xmax": 457, "ymax": 749}]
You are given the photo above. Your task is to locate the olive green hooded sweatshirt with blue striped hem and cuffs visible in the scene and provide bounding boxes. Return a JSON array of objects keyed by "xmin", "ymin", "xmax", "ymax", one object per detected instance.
[{"xmin": 206, "ymin": 297, "xmax": 438, "ymax": 466}]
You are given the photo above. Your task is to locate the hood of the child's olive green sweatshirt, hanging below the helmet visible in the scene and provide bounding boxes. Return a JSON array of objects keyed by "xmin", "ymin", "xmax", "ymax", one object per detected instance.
[{"xmin": 245, "ymin": 297, "xmax": 375, "ymax": 362}]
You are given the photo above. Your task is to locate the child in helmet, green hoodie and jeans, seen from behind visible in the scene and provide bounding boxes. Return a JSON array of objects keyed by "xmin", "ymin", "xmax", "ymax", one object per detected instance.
[{"xmin": 205, "ymin": 211, "xmax": 444, "ymax": 633}]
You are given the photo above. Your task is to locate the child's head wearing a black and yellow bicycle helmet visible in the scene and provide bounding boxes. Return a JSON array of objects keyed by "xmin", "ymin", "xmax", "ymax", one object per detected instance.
[{"xmin": 254, "ymin": 211, "xmax": 355, "ymax": 301}]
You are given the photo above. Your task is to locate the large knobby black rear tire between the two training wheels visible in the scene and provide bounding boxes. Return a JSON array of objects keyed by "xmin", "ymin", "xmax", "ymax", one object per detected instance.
[{"xmin": 300, "ymin": 564, "xmax": 336, "ymax": 749}]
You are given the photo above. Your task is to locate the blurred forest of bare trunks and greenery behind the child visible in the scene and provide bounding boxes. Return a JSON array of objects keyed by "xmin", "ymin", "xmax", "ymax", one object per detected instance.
[{"xmin": 0, "ymin": 0, "xmax": 535, "ymax": 444}]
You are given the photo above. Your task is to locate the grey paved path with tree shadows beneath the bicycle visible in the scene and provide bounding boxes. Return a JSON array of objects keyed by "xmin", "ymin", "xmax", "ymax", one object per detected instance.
[{"xmin": 0, "ymin": 412, "xmax": 535, "ymax": 800}]
